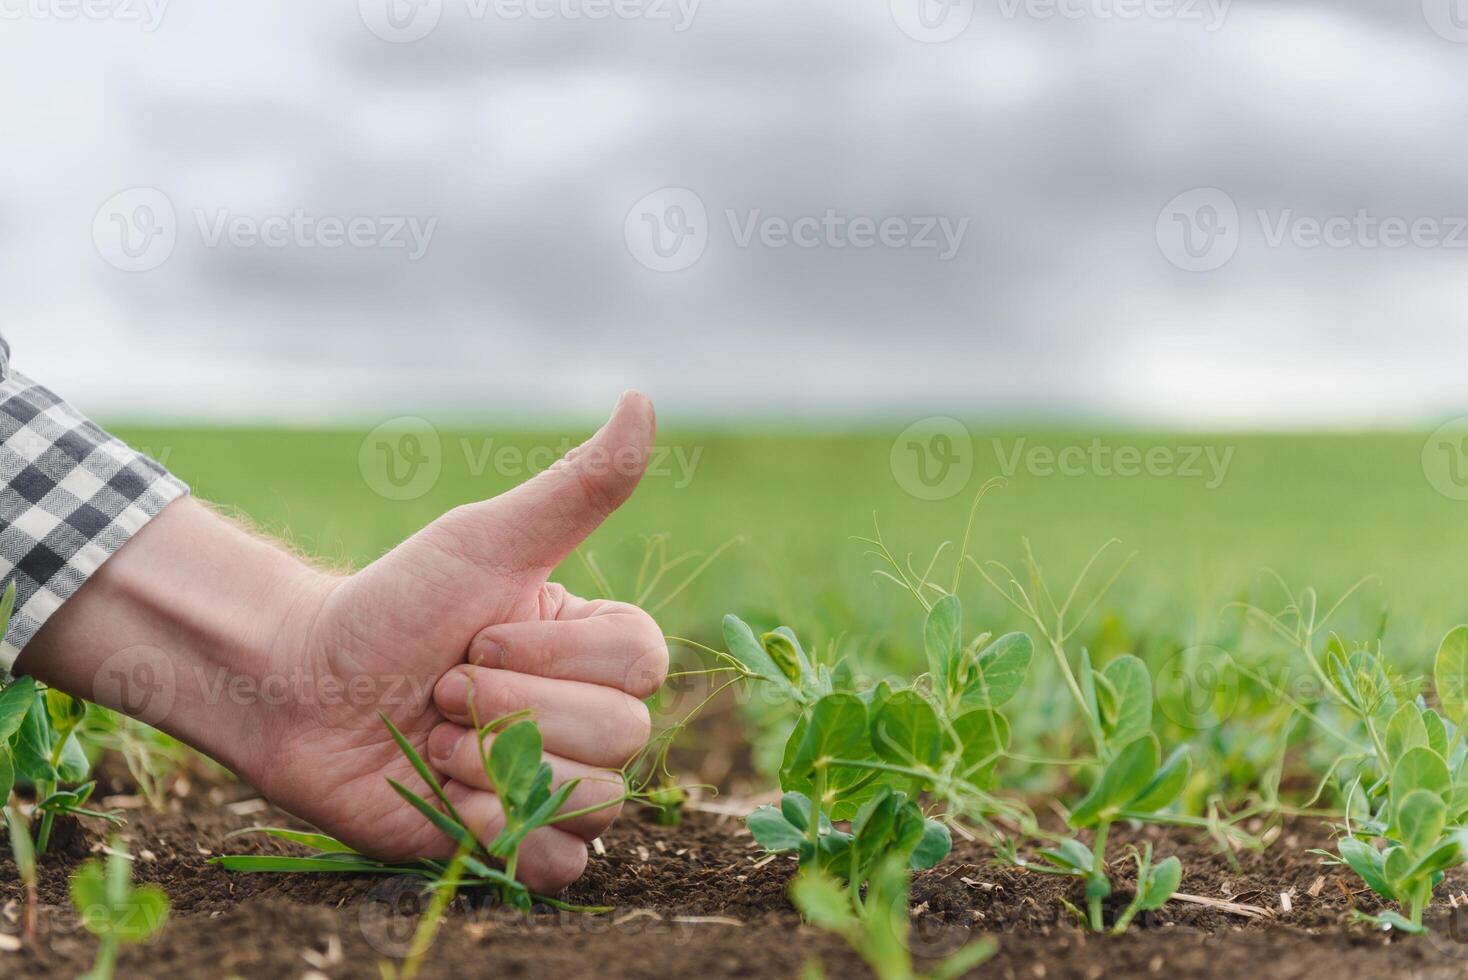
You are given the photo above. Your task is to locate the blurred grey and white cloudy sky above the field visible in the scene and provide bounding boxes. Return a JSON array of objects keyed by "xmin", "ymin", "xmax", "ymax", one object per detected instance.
[{"xmin": 0, "ymin": 0, "xmax": 1468, "ymax": 425}]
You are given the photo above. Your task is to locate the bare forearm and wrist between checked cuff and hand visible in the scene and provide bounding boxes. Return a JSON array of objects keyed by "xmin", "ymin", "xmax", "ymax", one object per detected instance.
[{"xmin": 15, "ymin": 497, "xmax": 338, "ymax": 778}]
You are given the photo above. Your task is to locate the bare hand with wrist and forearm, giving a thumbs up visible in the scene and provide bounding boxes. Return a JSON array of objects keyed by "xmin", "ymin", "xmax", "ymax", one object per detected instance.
[{"xmin": 18, "ymin": 395, "xmax": 668, "ymax": 893}]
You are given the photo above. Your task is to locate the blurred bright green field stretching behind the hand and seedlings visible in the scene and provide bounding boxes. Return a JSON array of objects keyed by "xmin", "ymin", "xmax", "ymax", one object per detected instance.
[{"xmin": 106, "ymin": 425, "xmax": 1468, "ymax": 677}]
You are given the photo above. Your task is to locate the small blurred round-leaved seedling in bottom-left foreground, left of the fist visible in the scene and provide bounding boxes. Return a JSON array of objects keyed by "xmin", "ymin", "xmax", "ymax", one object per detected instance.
[{"xmin": 70, "ymin": 838, "xmax": 169, "ymax": 980}]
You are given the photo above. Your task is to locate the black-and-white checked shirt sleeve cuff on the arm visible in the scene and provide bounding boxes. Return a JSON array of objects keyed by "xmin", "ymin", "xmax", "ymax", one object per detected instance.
[{"xmin": 0, "ymin": 371, "xmax": 188, "ymax": 670}]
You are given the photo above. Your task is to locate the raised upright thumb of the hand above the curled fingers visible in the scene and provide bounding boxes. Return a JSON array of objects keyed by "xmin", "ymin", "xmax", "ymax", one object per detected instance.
[{"xmin": 468, "ymin": 392, "xmax": 658, "ymax": 569}]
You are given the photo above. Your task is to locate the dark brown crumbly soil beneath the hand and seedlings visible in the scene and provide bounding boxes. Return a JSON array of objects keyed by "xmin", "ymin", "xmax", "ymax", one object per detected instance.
[{"xmin": 0, "ymin": 762, "xmax": 1468, "ymax": 980}]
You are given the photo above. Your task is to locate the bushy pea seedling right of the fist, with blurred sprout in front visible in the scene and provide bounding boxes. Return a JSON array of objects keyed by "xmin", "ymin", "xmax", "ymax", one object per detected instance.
[{"xmin": 724, "ymin": 594, "xmax": 1032, "ymax": 980}]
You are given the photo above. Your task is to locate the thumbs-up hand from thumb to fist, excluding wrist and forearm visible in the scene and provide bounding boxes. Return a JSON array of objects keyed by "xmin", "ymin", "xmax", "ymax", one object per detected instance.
[{"xmin": 247, "ymin": 393, "xmax": 668, "ymax": 893}]
